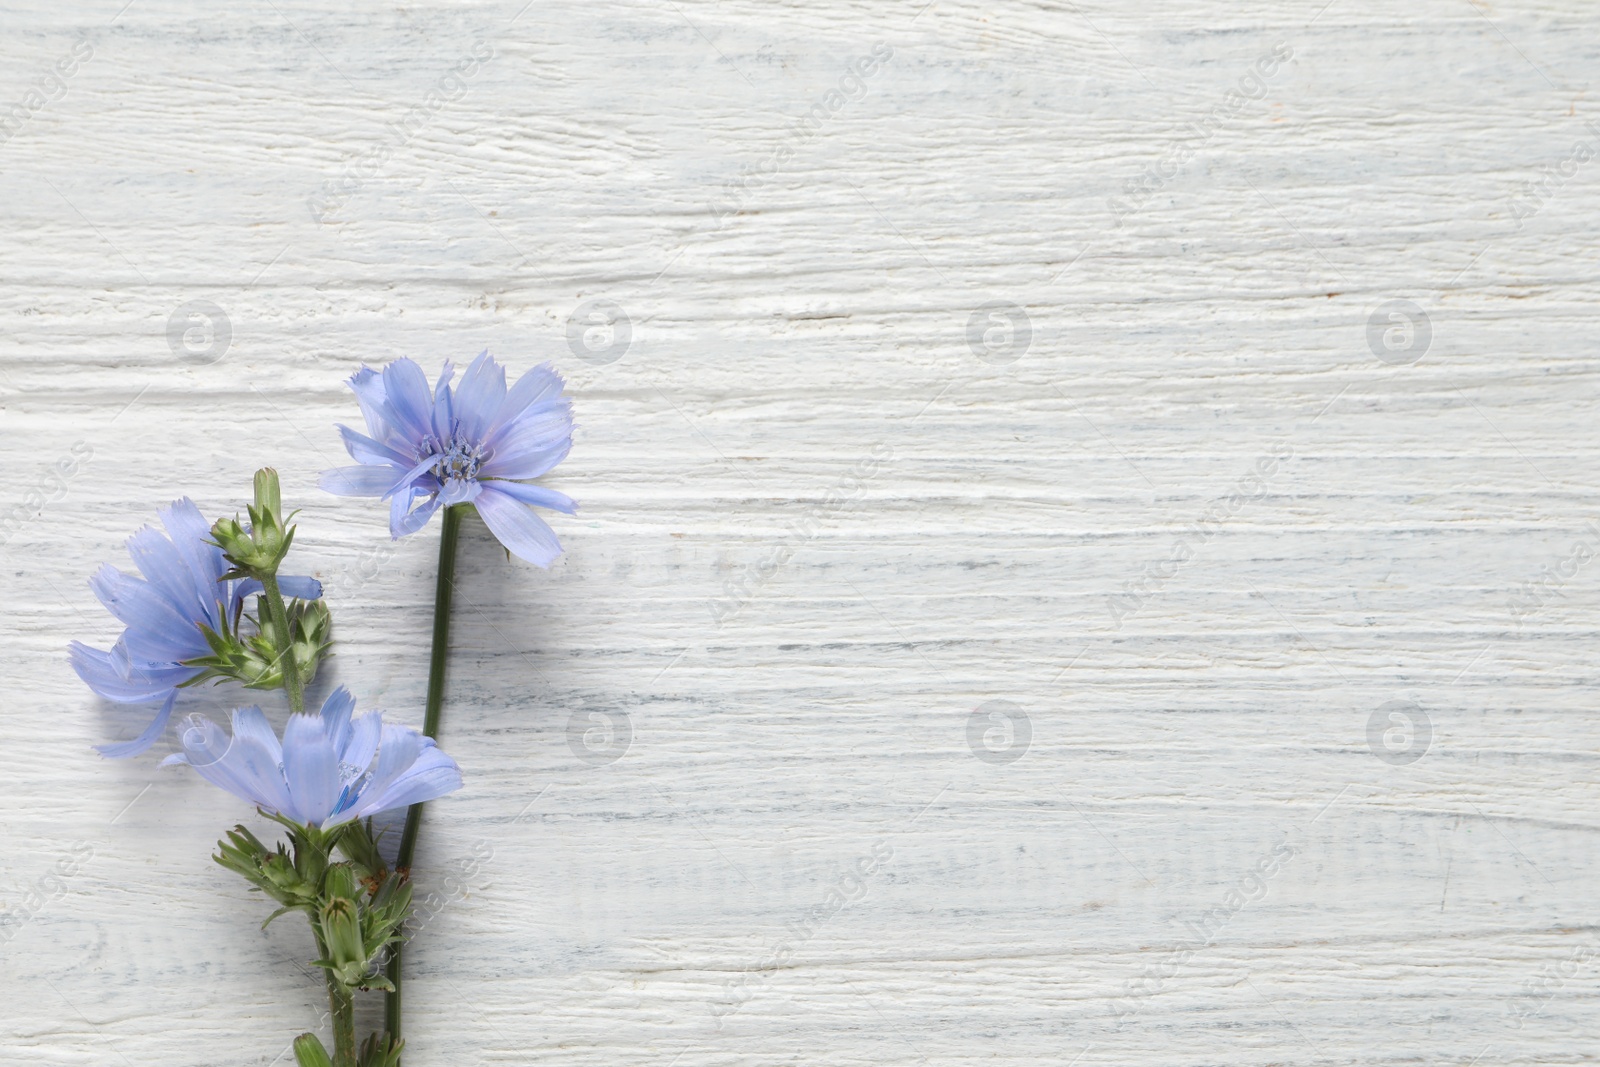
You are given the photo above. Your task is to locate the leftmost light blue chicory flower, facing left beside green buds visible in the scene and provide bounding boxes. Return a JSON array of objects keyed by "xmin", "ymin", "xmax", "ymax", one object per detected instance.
[{"xmin": 70, "ymin": 498, "xmax": 322, "ymax": 757}]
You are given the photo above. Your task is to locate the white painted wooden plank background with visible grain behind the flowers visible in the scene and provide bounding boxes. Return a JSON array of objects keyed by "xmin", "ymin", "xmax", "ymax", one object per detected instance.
[{"xmin": 0, "ymin": 0, "xmax": 1600, "ymax": 1067}]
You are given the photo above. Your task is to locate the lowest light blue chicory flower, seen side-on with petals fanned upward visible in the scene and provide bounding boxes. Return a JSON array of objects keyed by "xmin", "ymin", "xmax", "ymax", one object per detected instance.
[{"xmin": 162, "ymin": 686, "xmax": 461, "ymax": 830}]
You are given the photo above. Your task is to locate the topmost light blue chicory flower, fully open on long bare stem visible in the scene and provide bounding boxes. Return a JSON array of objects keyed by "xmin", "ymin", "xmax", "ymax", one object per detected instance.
[{"xmin": 322, "ymin": 352, "xmax": 578, "ymax": 566}]
